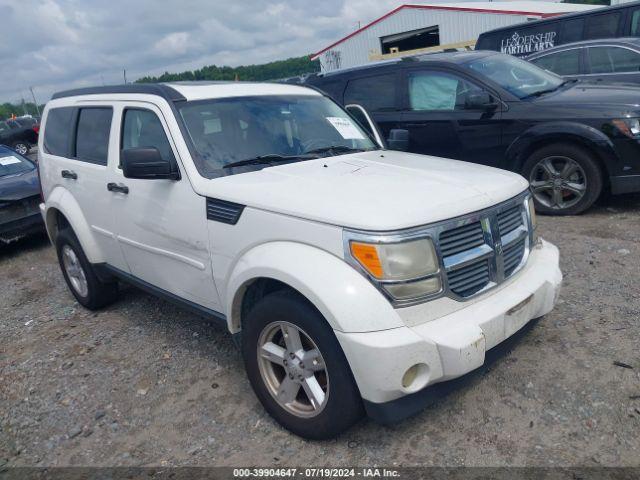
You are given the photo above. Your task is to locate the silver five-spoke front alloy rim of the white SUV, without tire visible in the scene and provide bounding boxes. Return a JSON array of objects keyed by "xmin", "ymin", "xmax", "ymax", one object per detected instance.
[{"xmin": 257, "ymin": 322, "xmax": 329, "ymax": 418}]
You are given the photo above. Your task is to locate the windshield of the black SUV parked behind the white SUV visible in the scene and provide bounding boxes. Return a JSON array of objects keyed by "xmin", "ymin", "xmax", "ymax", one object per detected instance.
[{"xmin": 466, "ymin": 55, "xmax": 563, "ymax": 99}]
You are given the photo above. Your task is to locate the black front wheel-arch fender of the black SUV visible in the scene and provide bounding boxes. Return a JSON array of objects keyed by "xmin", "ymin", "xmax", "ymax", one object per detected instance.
[{"xmin": 503, "ymin": 121, "xmax": 619, "ymax": 174}]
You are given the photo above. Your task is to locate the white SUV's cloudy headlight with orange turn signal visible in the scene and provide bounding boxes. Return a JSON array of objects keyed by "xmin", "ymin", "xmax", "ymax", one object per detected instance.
[{"xmin": 347, "ymin": 238, "xmax": 442, "ymax": 301}]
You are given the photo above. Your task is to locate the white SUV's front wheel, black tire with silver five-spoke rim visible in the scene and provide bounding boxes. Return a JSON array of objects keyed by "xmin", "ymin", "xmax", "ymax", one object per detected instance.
[{"xmin": 242, "ymin": 291, "xmax": 363, "ymax": 439}]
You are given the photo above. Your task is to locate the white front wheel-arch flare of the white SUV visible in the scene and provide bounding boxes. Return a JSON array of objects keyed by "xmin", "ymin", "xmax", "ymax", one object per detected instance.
[{"xmin": 226, "ymin": 242, "xmax": 403, "ymax": 333}]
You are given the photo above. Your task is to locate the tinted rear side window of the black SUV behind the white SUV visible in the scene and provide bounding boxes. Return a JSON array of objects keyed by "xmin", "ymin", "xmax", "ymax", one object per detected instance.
[{"xmin": 344, "ymin": 73, "xmax": 397, "ymax": 112}]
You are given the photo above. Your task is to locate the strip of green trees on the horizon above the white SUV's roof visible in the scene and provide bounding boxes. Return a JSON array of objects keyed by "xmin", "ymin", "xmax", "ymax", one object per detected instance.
[{"xmin": 136, "ymin": 55, "xmax": 320, "ymax": 83}]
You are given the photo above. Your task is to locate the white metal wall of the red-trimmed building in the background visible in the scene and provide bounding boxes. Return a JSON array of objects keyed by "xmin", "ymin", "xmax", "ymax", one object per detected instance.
[{"xmin": 320, "ymin": 8, "xmax": 527, "ymax": 71}]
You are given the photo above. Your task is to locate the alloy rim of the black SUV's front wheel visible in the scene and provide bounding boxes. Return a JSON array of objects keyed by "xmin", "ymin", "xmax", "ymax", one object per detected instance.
[{"xmin": 529, "ymin": 156, "xmax": 587, "ymax": 210}]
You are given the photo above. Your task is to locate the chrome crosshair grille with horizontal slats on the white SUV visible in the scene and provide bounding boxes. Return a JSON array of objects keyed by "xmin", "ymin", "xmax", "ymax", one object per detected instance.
[{"xmin": 437, "ymin": 196, "xmax": 530, "ymax": 298}]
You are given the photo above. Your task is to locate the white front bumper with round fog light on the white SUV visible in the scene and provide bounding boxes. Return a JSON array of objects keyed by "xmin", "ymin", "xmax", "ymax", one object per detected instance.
[{"xmin": 336, "ymin": 240, "xmax": 562, "ymax": 421}]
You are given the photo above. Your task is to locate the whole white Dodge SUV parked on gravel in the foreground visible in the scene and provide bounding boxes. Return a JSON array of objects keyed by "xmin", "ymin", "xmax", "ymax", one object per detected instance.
[{"xmin": 38, "ymin": 83, "xmax": 562, "ymax": 438}]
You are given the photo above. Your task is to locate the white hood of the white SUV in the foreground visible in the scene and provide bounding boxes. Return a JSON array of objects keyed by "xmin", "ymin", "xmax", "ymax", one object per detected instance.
[{"xmin": 200, "ymin": 151, "xmax": 528, "ymax": 231}]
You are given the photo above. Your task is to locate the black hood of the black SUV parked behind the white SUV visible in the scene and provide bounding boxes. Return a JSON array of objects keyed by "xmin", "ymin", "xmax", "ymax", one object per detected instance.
[{"xmin": 535, "ymin": 82, "xmax": 640, "ymax": 113}]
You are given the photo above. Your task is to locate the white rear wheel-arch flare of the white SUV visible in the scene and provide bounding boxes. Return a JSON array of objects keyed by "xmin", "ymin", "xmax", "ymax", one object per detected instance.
[{"xmin": 44, "ymin": 187, "xmax": 105, "ymax": 263}]
